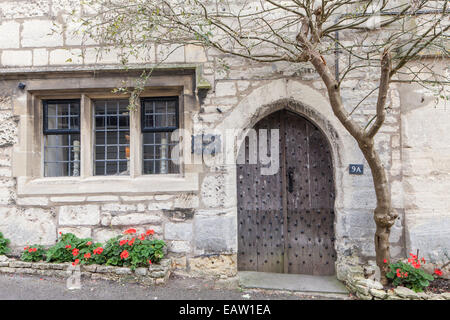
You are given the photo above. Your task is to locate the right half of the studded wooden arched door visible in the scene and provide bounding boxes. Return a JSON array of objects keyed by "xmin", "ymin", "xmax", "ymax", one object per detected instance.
[{"xmin": 284, "ymin": 112, "xmax": 336, "ymax": 275}]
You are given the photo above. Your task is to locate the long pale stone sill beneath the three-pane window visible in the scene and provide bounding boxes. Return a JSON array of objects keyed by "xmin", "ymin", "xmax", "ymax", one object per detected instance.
[{"xmin": 17, "ymin": 173, "xmax": 198, "ymax": 196}]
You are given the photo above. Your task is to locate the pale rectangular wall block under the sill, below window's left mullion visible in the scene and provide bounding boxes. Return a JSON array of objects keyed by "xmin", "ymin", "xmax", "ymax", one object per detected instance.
[{"xmin": 59, "ymin": 205, "xmax": 100, "ymax": 226}]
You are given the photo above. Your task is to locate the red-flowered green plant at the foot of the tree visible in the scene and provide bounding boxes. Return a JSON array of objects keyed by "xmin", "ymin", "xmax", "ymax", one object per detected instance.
[{"xmin": 386, "ymin": 255, "xmax": 434, "ymax": 292}]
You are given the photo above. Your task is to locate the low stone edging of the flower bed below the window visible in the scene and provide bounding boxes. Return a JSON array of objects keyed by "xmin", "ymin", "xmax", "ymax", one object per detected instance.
[{"xmin": 0, "ymin": 258, "xmax": 172, "ymax": 285}]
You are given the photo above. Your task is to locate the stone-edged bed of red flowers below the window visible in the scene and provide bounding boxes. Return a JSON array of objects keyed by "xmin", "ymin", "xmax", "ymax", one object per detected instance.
[{"xmin": 0, "ymin": 228, "xmax": 171, "ymax": 284}]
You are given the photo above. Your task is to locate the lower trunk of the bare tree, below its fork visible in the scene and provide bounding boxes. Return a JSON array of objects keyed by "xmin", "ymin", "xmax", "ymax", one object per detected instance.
[{"xmin": 358, "ymin": 138, "xmax": 398, "ymax": 284}]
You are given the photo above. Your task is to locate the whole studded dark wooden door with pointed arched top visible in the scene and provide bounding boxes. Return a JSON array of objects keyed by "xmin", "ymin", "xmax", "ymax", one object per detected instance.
[{"xmin": 236, "ymin": 110, "xmax": 336, "ymax": 275}]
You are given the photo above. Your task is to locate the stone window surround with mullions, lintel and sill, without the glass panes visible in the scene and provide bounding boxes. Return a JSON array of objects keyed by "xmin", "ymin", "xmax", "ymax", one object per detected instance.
[{"xmin": 8, "ymin": 69, "xmax": 199, "ymax": 196}]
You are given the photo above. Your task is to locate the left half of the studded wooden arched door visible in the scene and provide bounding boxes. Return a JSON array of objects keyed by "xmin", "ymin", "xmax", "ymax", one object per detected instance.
[{"xmin": 237, "ymin": 113, "xmax": 284, "ymax": 272}]
